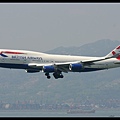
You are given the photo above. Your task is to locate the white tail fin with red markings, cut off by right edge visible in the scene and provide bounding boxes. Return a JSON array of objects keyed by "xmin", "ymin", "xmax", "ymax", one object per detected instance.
[{"xmin": 105, "ymin": 45, "xmax": 120, "ymax": 60}]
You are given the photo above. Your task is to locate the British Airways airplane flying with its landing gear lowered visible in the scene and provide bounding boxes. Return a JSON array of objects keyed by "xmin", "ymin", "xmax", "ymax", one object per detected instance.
[{"xmin": 0, "ymin": 45, "xmax": 120, "ymax": 79}]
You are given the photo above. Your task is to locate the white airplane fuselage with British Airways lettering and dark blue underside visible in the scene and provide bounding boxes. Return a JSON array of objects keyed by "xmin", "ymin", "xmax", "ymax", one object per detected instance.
[{"xmin": 0, "ymin": 49, "xmax": 120, "ymax": 70}]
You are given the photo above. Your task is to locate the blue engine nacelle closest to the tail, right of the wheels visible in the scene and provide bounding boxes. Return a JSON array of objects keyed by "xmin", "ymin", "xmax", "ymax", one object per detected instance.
[{"xmin": 69, "ymin": 63, "xmax": 83, "ymax": 72}]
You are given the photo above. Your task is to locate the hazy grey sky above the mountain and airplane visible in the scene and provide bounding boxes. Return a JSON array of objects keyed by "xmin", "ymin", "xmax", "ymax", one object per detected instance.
[{"xmin": 0, "ymin": 3, "xmax": 120, "ymax": 52}]
